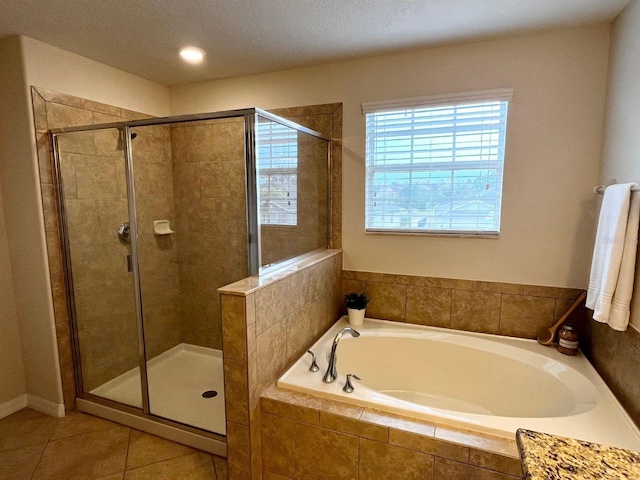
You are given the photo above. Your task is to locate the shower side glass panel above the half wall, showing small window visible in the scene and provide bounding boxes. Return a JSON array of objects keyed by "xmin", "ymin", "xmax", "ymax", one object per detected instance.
[{"xmin": 256, "ymin": 115, "xmax": 329, "ymax": 267}]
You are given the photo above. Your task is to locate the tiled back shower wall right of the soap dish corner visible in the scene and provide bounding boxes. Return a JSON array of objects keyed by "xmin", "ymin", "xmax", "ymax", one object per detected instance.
[{"xmin": 171, "ymin": 118, "xmax": 248, "ymax": 349}]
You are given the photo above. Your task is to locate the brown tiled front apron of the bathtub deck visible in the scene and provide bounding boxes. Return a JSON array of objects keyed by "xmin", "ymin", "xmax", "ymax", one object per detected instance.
[{"xmin": 260, "ymin": 387, "xmax": 522, "ymax": 480}]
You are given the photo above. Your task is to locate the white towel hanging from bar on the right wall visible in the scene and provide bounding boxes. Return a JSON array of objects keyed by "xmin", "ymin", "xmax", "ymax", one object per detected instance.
[{"xmin": 586, "ymin": 183, "xmax": 640, "ymax": 330}]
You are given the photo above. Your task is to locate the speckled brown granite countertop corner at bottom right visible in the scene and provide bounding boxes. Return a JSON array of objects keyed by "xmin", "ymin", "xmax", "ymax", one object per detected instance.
[{"xmin": 516, "ymin": 428, "xmax": 640, "ymax": 480}]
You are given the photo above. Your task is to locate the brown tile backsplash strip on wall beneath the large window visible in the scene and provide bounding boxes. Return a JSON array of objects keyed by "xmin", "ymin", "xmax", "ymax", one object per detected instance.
[{"xmin": 342, "ymin": 270, "xmax": 585, "ymax": 338}]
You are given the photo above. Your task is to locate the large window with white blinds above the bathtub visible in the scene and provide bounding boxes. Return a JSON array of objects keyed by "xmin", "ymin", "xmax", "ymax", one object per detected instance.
[{"xmin": 362, "ymin": 89, "xmax": 513, "ymax": 235}]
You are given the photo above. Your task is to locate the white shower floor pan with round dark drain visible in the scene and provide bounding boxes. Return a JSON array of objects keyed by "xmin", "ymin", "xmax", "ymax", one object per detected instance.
[{"xmin": 90, "ymin": 343, "xmax": 226, "ymax": 435}]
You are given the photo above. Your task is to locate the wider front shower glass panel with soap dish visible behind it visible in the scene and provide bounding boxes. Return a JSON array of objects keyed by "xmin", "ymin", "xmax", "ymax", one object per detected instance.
[{"xmin": 131, "ymin": 117, "xmax": 249, "ymax": 435}]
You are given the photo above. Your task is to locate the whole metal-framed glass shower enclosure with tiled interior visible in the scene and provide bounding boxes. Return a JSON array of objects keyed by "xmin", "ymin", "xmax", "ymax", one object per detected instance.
[{"xmin": 52, "ymin": 109, "xmax": 330, "ymax": 453}]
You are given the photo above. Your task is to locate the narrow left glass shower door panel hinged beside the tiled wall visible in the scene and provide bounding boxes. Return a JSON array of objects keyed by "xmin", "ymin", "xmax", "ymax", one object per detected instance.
[{"xmin": 57, "ymin": 128, "xmax": 143, "ymax": 408}]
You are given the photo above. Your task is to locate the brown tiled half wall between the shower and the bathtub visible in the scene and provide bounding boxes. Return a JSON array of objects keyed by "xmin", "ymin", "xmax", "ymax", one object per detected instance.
[{"xmin": 220, "ymin": 250, "xmax": 342, "ymax": 480}]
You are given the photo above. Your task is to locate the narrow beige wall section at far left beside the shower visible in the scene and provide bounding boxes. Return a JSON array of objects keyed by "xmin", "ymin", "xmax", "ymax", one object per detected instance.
[{"xmin": 0, "ymin": 37, "xmax": 62, "ymax": 411}]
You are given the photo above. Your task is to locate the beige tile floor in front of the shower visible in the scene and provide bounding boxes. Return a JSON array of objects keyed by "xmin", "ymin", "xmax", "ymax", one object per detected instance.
[{"xmin": 0, "ymin": 408, "xmax": 227, "ymax": 480}]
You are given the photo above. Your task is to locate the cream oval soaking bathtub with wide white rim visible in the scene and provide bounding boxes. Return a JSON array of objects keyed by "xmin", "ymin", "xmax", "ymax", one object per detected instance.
[{"xmin": 277, "ymin": 317, "xmax": 640, "ymax": 451}]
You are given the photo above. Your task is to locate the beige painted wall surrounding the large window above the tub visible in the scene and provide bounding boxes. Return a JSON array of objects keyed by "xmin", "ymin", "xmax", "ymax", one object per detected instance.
[{"xmin": 171, "ymin": 25, "xmax": 609, "ymax": 287}]
